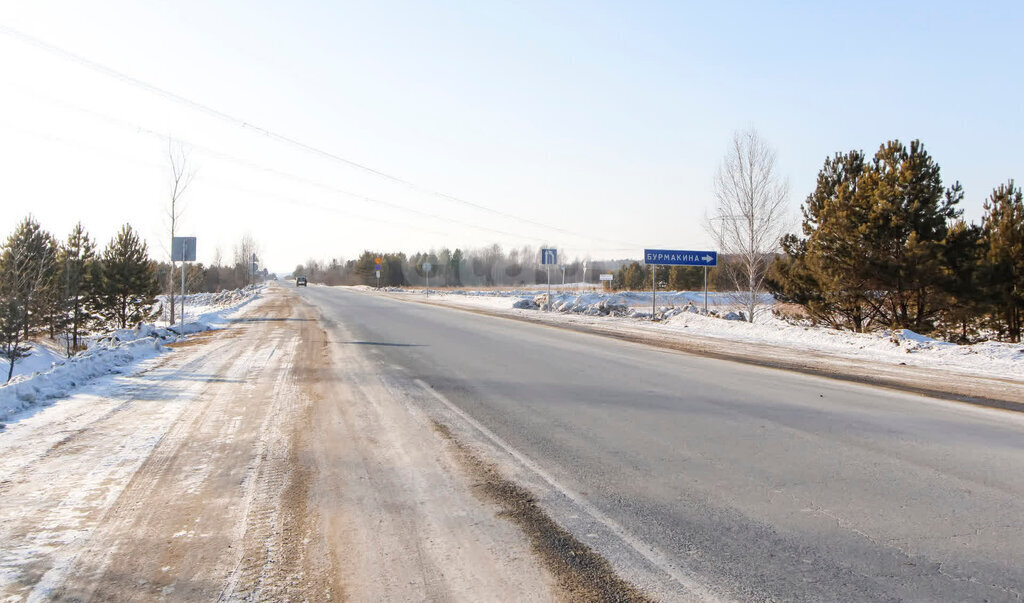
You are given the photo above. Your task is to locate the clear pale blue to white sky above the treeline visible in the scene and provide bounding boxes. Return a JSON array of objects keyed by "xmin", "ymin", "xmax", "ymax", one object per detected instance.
[{"xmin": 0, "ymin": 0, "xmax": 1024, "ymax": 271}]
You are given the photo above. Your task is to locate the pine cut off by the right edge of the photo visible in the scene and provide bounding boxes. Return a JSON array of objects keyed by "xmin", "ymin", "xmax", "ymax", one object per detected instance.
[{"xmin": 982, "ymin": 180, "xmax": 1024, "ymax": 342}]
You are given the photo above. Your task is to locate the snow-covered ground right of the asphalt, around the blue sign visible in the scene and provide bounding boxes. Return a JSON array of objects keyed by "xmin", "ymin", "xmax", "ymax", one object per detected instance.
[{"xmin": 378, "ymin": 288, "xmax": 1024, "ymax": 381}]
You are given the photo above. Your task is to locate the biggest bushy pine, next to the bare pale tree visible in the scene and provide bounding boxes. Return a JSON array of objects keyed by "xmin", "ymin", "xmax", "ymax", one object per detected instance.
[{"xmin": 773, "ymin": 140, "xmax": 964, "ymax": 332}]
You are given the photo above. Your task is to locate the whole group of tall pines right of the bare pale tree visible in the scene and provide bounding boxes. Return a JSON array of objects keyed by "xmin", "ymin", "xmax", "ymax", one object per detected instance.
[{"xmin": 768, "ymin": 140, "xmax": 1024, "ymax": 342}]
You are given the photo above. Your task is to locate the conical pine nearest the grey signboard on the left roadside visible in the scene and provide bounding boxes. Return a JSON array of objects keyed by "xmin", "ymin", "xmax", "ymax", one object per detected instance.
[{"xmin": 100, "ymin": 224, "xmax": 160, "ymax": 329}]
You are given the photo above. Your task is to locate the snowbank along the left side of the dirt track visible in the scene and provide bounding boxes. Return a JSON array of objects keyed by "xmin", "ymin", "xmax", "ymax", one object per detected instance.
[{"xmin": 0, "ymin": 287, "xmax": 262, "ymax": 425}]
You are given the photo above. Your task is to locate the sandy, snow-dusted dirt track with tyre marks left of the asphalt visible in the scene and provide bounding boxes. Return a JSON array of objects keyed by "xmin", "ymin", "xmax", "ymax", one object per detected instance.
[{"xmin": 0, "ymin": 288, "xmax": 557, "ymax": 601}]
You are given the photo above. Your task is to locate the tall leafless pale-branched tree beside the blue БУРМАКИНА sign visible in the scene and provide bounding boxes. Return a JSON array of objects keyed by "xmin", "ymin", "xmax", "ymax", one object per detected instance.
[{"xmin": 706, "ymin": 129, "xmax": 790, "ymax": 322}]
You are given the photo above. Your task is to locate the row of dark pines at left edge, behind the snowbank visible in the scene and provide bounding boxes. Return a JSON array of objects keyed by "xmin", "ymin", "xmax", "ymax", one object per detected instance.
[{"xmin": 0, "ymin": 216, "xmax": 159, "ymax": 381}]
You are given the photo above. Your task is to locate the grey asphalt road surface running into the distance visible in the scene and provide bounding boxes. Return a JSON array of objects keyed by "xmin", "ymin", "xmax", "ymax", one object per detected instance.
[{"xmin": 294, "ymin": 287, "xmax": 1024, "ymax": 601}]
